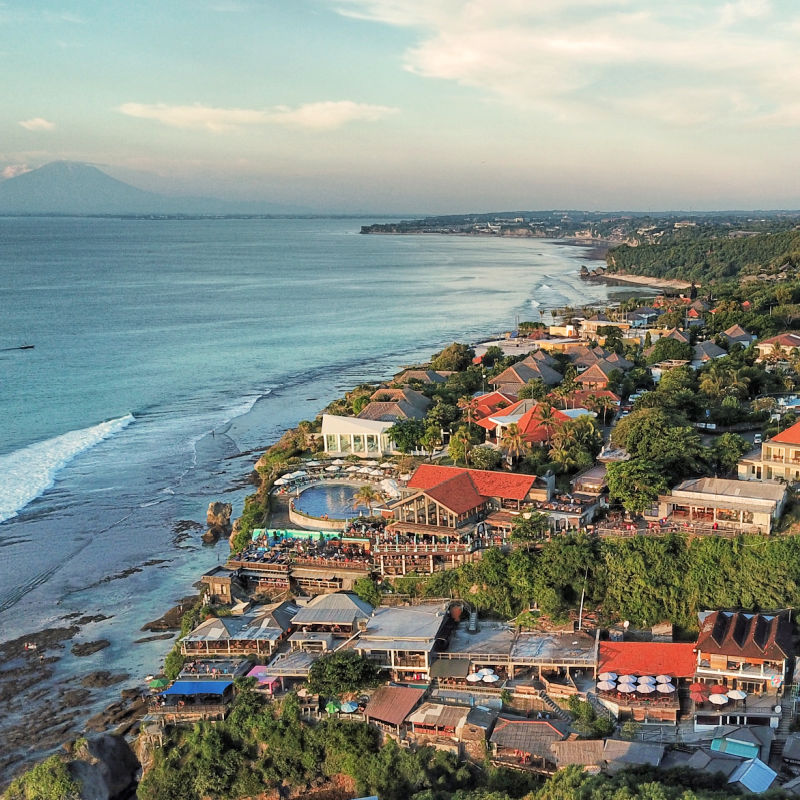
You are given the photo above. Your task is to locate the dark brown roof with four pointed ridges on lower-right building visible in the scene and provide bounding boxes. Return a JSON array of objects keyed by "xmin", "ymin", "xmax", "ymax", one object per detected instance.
[{"xmin": 697, "ymin": 611, "xmax": 792, "ymax": 661}]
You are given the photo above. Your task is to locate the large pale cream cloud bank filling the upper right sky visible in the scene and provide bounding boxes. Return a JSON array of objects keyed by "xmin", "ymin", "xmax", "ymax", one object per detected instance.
[{"xmin": 327, "ymin": 0, "xmax": 800, "ymax": 127}]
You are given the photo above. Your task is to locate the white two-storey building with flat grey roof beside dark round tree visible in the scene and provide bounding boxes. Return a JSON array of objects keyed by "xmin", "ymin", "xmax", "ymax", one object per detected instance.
[{"xmin": 353, "ymin": 603, "xmax": 450, "ymax": 683}]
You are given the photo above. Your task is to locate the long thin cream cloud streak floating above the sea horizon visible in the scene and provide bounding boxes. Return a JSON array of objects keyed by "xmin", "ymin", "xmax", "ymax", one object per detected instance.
[{"xmin": 117, "ymin": 100, "xmax": 397, "ymax": 132}]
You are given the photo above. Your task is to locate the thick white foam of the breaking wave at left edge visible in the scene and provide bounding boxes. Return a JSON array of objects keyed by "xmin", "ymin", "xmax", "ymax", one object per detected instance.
[{"xmin": 0, "ymin": 414, "xmax": 134, "ymax": 522}]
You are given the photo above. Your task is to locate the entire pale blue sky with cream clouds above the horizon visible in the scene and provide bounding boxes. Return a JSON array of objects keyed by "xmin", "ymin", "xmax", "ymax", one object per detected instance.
[{"xmin": 0, "ymin": 0, "xmax": 800, "ymax": 214}]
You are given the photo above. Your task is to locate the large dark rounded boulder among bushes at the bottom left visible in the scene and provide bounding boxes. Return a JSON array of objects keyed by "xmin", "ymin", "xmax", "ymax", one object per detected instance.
[{"xmin": 69, "ymin": 733, "xmax": 140, "ymax": 800}]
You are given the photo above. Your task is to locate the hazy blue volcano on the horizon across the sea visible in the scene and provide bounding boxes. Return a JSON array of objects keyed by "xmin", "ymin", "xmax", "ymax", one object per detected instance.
[{"xmin": 0, "ymin": 161, "xmax": 309, "ymax": 214}]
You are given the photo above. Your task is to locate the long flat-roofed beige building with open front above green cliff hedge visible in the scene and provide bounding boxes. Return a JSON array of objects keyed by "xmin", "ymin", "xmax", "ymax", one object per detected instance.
[{"xmin": 658, "ymin": 478, "xmax": 786, "ymax": 533}]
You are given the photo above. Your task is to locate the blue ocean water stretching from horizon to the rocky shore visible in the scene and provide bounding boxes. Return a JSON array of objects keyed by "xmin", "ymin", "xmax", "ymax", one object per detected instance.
[{"xmin": 0, "ymin": 218, "xmax": 614, "ymax": 764}]
